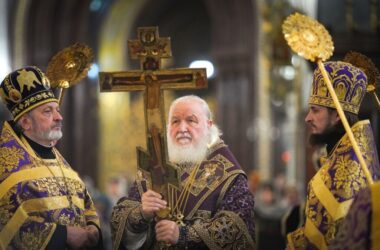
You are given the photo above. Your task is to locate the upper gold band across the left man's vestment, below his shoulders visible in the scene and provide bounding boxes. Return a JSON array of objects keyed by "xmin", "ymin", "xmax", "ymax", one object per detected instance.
[{"xmin": 0, "ymin": 166, "xmax": 82, "ymax": 199}]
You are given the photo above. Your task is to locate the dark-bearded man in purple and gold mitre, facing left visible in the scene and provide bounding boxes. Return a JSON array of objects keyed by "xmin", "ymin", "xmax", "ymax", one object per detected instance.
[{"xmin": 287, "ymin": 61, "xmax": 380, "ymax": 249}]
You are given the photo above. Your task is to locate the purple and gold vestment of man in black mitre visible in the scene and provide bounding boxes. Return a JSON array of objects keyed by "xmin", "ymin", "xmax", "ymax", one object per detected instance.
[{"xmin": 0, "ymin": 122, "xmax": 99, "ymax": 249}]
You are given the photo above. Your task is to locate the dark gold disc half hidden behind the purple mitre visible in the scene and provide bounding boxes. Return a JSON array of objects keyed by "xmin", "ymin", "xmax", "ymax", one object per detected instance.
[{"xmin": 343, "ymin": 51, "xmax": 380, "ymax": 108}]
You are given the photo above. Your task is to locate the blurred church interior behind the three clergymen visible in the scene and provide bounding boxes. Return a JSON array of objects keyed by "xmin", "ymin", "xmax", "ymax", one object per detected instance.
[{"xmin": 0, "ymin": 0, "xmax": 380, "ymax": 249}]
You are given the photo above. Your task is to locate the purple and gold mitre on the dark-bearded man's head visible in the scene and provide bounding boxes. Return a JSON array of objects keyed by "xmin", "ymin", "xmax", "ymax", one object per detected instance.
[{"xmin": 309, "ymin": 61, "xmax": 367, "ymax": 114}]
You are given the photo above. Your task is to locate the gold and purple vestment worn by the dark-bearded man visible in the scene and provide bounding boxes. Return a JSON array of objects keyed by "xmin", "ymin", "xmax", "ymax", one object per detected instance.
[{"xmin": 287, "ymin": 120, "xmax": 380, "ymax": 249}]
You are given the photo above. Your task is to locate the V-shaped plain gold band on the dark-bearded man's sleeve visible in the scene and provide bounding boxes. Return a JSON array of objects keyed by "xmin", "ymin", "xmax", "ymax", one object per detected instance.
[{"xmin": 311, "ymin": 171, "xmax": 352, "ymax": 221}]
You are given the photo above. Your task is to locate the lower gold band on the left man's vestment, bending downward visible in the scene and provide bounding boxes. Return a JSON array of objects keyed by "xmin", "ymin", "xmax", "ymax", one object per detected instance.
[{"xmin": 0, "ymin": 196, "xmax": 84, "ymax": 249}]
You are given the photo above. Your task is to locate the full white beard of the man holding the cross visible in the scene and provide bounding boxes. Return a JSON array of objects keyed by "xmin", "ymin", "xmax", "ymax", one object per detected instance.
[{"xmin": 167, "ymin": 134, "xmax": 210, "ymax": 164}]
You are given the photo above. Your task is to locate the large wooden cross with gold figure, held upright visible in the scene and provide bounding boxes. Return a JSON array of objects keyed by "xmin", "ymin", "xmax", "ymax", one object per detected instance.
[{"xmin": 99, "ymin": 27, "xmax": 207, "ymax": 198}]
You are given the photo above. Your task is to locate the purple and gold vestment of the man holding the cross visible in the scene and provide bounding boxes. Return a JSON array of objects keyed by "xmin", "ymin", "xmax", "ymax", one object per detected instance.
[{"xmin": 111, "ymin": 140, "xmax": 255, "ymax": 249}]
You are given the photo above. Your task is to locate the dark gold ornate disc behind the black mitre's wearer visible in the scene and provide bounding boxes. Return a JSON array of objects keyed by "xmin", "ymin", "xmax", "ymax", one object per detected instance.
[{"xmin": 46, "ymin": 43, "xmax": 94, "ymax": 104}]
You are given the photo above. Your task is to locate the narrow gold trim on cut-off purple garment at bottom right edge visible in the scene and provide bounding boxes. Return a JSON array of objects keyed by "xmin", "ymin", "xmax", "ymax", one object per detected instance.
[{"xmin": 371, "ymin": 182, "xmax": 380, "ymax": 250}]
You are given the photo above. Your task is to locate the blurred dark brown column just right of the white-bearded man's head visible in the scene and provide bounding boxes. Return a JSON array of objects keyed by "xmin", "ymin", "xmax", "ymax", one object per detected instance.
[{"xmin": 206, "ymin": 0, "xmax": 259, "ymax": 173}]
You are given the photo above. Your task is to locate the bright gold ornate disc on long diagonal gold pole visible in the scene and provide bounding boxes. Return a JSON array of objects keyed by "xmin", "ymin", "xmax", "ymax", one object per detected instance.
[{"xmin": 282, "ymin": 13, "xmax": 373, "ymax": 184}]
